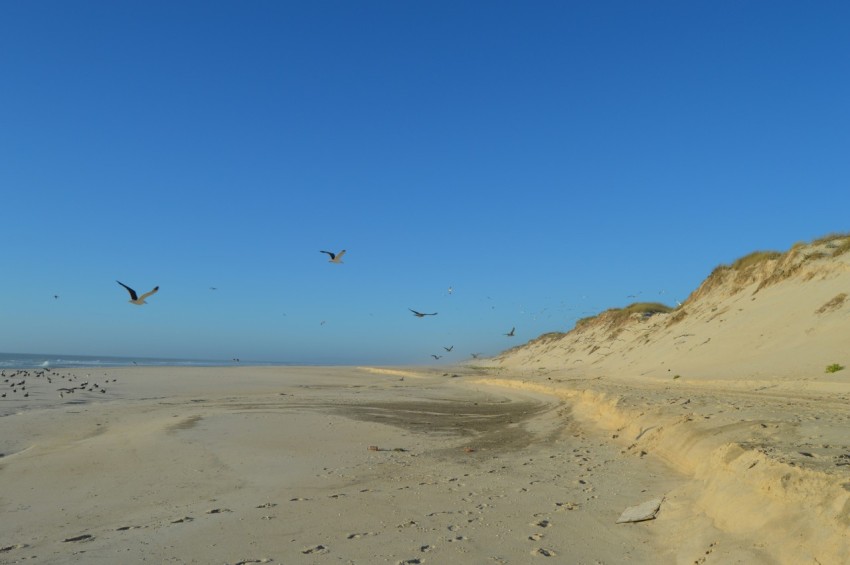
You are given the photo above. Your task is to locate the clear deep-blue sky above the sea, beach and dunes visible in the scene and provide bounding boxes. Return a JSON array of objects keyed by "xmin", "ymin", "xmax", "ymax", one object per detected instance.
[{"xmin": 0, "ymin": 0, "xmax": 850, "ymax": 364}]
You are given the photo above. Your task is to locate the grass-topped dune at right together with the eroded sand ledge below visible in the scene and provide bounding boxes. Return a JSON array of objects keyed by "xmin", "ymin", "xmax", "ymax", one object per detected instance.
[{"xmin": 479, "ymin": 232, "xmax": 850, "ymax": 564}]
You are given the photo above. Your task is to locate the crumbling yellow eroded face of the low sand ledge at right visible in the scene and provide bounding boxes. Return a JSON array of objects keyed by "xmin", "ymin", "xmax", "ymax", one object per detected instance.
[{"xmin": 470, "ymin": 378, "xmax": 850, "ymax": 563}]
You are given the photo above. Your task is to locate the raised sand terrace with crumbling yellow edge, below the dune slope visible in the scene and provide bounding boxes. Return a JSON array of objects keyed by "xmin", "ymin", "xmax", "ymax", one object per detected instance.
[{"xmin": 470, "ymin": 371, "xmax": 850, "ymax": 565}]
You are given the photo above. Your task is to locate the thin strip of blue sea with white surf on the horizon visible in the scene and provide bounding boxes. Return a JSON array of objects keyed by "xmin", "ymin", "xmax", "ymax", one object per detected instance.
[{"xmin": 0, "ymin": 353, "xmax": 252, "ymax": 369}]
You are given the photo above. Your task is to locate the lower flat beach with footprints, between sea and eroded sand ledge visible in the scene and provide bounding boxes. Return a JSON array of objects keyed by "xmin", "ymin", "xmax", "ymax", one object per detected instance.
[{"xmin": 0, "ymin": 367, "xmax": 682, "ymax": 564}]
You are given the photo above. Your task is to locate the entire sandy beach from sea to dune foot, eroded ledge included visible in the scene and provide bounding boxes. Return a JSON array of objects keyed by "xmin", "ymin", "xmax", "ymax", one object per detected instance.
[{"xmin": 0, "ymin": 367, "xmax": 850, "ymax": 564}]
